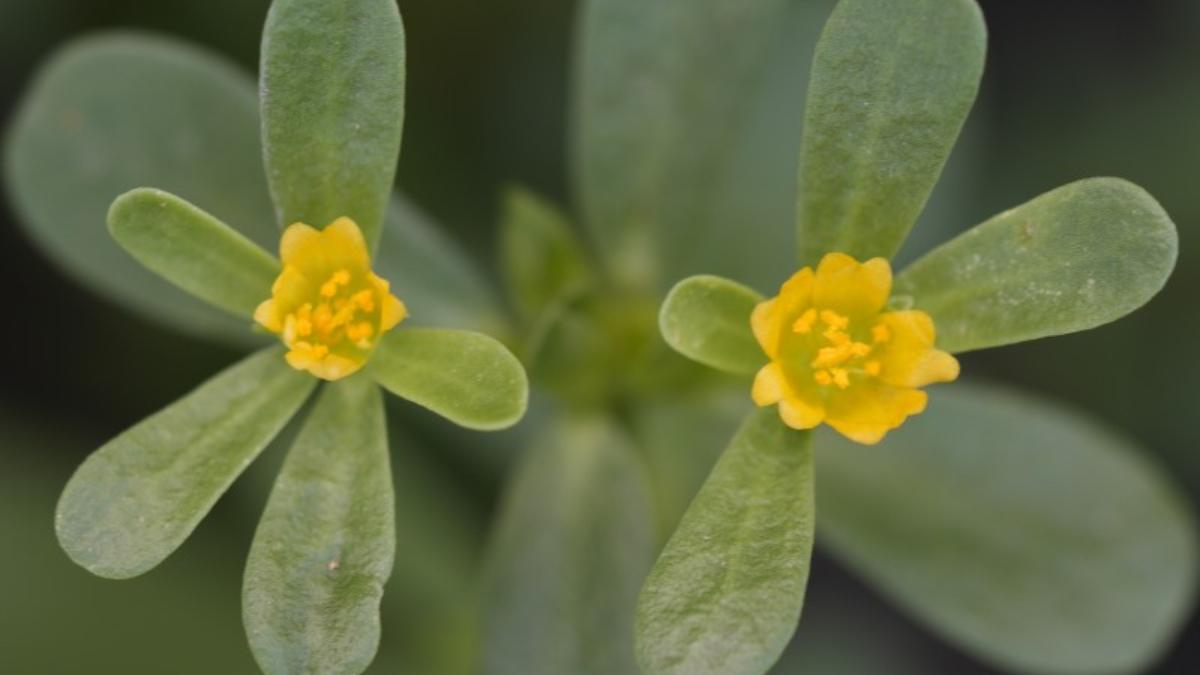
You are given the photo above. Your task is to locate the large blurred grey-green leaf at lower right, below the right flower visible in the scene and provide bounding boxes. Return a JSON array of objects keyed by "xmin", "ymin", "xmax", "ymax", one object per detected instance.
[{"xmin": 817, "ymin": 383, "xmax": 1198, "ymax": 674}]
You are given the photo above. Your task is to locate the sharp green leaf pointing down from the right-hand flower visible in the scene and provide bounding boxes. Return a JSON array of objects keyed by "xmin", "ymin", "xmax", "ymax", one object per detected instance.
[{"xmin": 635, "ymin": 410, "xmax": 814, "ymax": 675}]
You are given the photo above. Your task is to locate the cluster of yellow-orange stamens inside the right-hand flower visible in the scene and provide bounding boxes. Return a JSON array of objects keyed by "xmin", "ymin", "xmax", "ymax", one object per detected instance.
[{"xmin": 792, "ymin": 307, "xmax": 892, "ymax": 389}]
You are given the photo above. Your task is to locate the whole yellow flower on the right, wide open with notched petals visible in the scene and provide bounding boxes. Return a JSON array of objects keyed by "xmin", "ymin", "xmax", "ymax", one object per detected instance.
[{"xmin": 750, "ymin": 253, "xmax": 959, "ymax": 444}]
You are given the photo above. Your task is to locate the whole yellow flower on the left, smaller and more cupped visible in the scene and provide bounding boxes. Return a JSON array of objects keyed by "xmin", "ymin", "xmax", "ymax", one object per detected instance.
[{"xmin": 254, "ymin": 217, "xmax": 408, "ymax": 380}]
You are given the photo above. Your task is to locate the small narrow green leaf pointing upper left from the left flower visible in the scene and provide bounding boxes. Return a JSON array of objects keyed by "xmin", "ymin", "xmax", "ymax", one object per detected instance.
[{"xmin": 108, "ymin": 187, "xmax": 280, "ymax": 318}]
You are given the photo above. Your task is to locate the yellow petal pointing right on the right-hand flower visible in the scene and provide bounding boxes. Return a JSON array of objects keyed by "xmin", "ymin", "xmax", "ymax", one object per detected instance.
[{"xmin": 880, "ymin": 310, "xmax": 959, "ymax": 387}]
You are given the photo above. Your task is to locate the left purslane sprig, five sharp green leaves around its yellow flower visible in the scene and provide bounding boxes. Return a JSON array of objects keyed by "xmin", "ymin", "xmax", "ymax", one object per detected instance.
[{"xmin": 11, "ymin": 0, "xmax": 528, "ymax": 673}]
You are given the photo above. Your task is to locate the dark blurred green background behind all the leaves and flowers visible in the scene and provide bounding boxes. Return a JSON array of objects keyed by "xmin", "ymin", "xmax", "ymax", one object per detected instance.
[{"xmin": 0, "ymin": 0, "xmax": 1200, "ymax": 675}]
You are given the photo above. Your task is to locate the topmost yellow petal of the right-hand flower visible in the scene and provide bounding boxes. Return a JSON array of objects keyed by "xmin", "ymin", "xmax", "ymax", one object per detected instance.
[{"xmin": 812, "ymin": 253, "xmax": 892, "ymax": 317}]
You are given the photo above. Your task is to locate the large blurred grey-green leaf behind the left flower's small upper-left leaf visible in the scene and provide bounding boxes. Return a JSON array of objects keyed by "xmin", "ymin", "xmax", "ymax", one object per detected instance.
[{"xmin": 5, "ymin": 34, "xmax": 278, "ymax": 345}]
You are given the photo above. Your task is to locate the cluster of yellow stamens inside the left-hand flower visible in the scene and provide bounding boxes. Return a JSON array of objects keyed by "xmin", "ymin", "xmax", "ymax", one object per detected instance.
[{"xmin": 283, "ymin": 269, "xmax": 378, "ymax": 359}]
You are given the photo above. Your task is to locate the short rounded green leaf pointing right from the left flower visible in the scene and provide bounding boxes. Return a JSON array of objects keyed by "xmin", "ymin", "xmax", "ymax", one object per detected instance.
[{"xmin": 371, "ymin": 328, "xmax": 529, "ymax": 430}]
